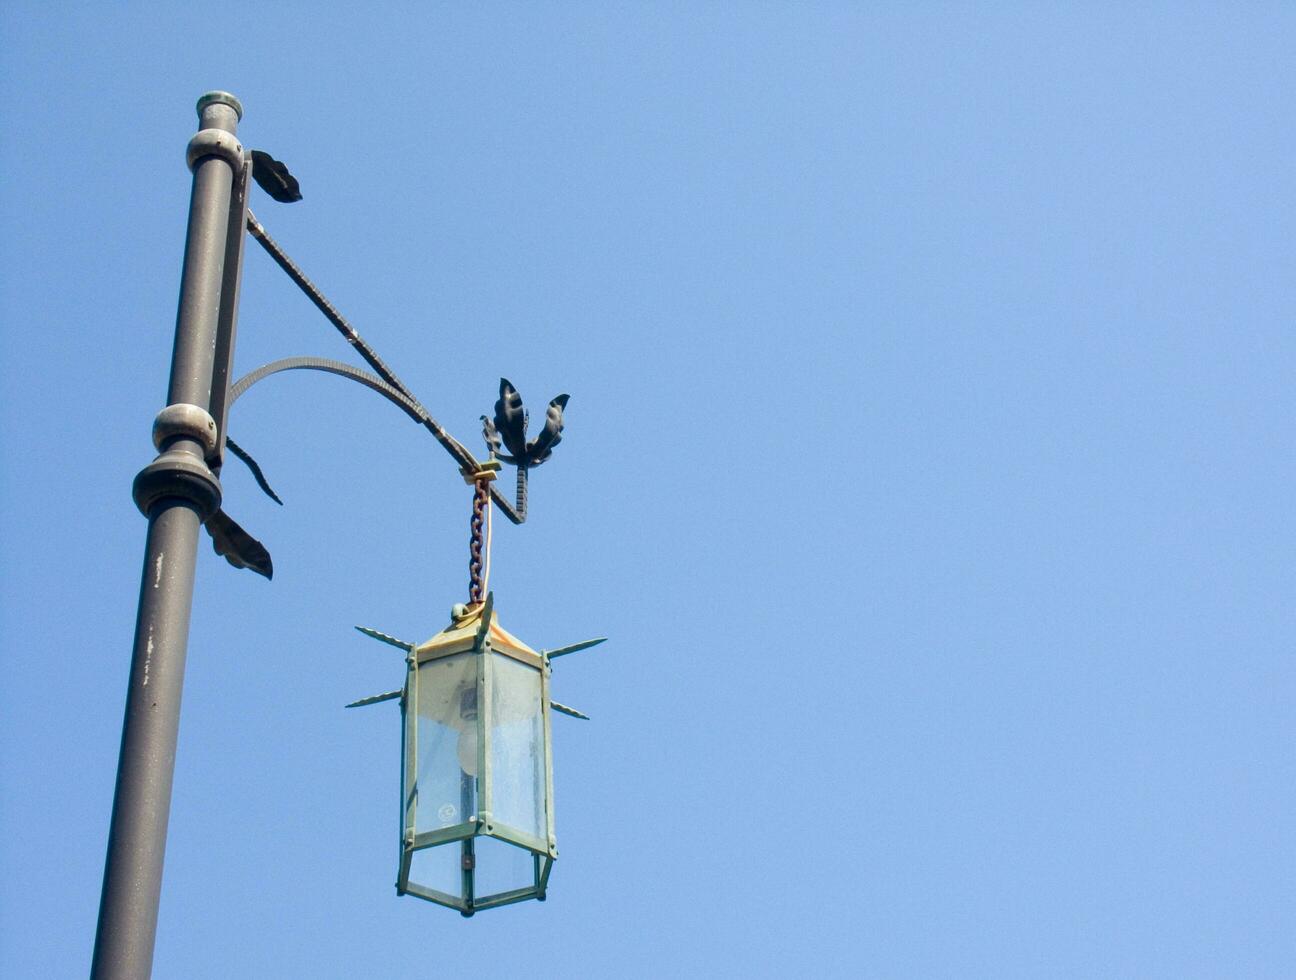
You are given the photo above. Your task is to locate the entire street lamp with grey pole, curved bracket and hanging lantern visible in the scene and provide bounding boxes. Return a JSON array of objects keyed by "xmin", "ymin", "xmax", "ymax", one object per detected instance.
[{"xmin": 91, "ymin": 92, "xmax": 600, "ymax": 980}]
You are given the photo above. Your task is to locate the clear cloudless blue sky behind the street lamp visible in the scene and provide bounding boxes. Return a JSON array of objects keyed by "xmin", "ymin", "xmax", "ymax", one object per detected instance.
[{"xmin": 0, "ymin": 3, "xmax": 1296, "ymax": 980}]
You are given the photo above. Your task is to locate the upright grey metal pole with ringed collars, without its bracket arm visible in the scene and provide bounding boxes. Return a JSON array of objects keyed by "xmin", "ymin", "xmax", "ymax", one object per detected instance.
[{"xmin": 91, "ymin": 92, "xmax": 246, "ymax": 980}]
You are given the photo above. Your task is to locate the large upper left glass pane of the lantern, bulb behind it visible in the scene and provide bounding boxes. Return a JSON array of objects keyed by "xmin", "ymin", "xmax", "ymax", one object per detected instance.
[{"xmin": 415, "ymin": 653, "xmax": 480, "ymax": 829}]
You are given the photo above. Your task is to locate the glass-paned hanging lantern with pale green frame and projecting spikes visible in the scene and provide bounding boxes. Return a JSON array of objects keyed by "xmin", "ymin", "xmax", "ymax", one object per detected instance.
[{"xmin": 347, "ymin": 595, "xmax": 603, "ymax": 915}]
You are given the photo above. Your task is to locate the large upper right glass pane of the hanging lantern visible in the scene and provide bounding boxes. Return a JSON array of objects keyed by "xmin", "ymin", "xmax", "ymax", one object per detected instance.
[{"xmin": 490, "ymin": 653, "xmax": 548, "ymax": 839}]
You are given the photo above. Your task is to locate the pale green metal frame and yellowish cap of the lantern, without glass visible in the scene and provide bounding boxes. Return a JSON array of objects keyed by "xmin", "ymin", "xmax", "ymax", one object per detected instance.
[{"xmin": 397, "ymin": 596, "xmax": 559, "ymax": 915}]
